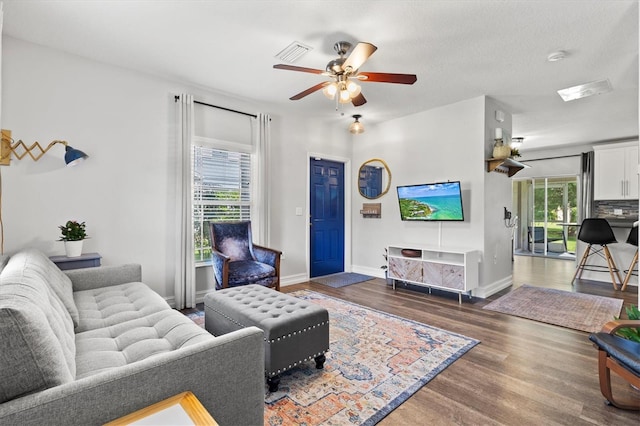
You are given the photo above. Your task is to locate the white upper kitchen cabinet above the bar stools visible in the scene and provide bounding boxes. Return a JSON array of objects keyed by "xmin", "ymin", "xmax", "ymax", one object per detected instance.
[{"xmin": 593, "ymin": 142, "xmax": 638, "ymax": 200}]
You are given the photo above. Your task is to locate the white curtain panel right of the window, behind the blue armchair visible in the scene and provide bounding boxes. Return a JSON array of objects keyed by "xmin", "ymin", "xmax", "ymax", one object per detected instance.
[{"xmin": 251, "ymin": 114, "xmax": 271, "ymax": 247}]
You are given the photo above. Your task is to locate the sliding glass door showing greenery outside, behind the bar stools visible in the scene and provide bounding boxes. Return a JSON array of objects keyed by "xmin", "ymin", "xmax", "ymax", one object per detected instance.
[{"xmin": 513, "ymin": 176, "xmax": 578, "ymax": 259}]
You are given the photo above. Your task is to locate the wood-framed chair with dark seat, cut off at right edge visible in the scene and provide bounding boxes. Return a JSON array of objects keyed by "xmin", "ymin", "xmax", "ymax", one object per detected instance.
[{"xmin": 589, "ymin": 320, "xmax": 640, "ymax": 410}]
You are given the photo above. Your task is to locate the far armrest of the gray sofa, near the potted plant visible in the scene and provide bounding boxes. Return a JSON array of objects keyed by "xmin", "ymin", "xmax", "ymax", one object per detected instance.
[{"xmin": 62, "ymin": 263, "xmax": 142, "ymax": 291}]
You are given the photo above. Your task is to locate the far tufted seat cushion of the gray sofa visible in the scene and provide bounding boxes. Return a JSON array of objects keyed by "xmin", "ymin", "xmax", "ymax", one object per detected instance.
[{"xmin": 74, "ymin": 283, "xmax": 171, "ymax": 333}]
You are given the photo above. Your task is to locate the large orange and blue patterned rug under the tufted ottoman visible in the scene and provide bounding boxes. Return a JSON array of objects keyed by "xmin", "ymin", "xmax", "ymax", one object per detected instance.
[{"xmin": 186, "ymin": 290, "xmax": 480, "ymax": 426}]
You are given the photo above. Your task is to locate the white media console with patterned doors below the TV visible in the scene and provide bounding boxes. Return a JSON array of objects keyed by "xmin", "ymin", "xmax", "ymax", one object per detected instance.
[{"xmin": 387, "ymin": 244, "xmax": 480, "ymax": 303}]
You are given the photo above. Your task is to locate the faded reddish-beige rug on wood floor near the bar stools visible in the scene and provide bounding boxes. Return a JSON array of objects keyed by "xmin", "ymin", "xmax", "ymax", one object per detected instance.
[{"xmin": 483, "ymin": 285, "xmax": 623, "ymax": 333}]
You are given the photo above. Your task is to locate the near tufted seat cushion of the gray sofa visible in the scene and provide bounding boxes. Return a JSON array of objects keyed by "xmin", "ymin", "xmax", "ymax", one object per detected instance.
[{"xmin": 76, "ymin": 309, "xmax": 214, "ymax": 378}]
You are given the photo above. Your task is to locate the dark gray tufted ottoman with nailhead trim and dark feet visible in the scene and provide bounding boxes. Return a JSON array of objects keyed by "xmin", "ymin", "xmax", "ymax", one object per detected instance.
[{"xmin": 204, "ymin": 284, "xmax": 329, "ymax": 392}]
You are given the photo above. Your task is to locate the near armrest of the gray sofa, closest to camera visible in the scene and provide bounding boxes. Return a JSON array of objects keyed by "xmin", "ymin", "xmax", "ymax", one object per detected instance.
[{"xmin": 0, "ymin": 327, "xmax": 265, "ymax": 426}]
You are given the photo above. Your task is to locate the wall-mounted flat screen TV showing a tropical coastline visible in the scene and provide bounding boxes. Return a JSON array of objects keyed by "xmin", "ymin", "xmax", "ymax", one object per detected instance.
[{"xmin": 397, "ymin": 181, "xmax": 464, "ymax": 221}]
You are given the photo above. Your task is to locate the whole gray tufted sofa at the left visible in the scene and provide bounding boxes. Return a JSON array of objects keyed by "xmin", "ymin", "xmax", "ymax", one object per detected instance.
[{"xmin": 0, "ymin": 249, "xmax": 264, "ymax": 425}]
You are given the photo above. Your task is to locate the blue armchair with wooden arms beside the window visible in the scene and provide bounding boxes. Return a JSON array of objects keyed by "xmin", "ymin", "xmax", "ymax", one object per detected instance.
[{"xmin": 209, "ymin": 221, "xmax": 282, "ymax": 291}]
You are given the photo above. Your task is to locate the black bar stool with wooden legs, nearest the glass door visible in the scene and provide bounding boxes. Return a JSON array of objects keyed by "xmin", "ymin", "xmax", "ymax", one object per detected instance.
[{"xmin": 571, "ymin": 219, "xmax": 622, "ymax": 290}]
